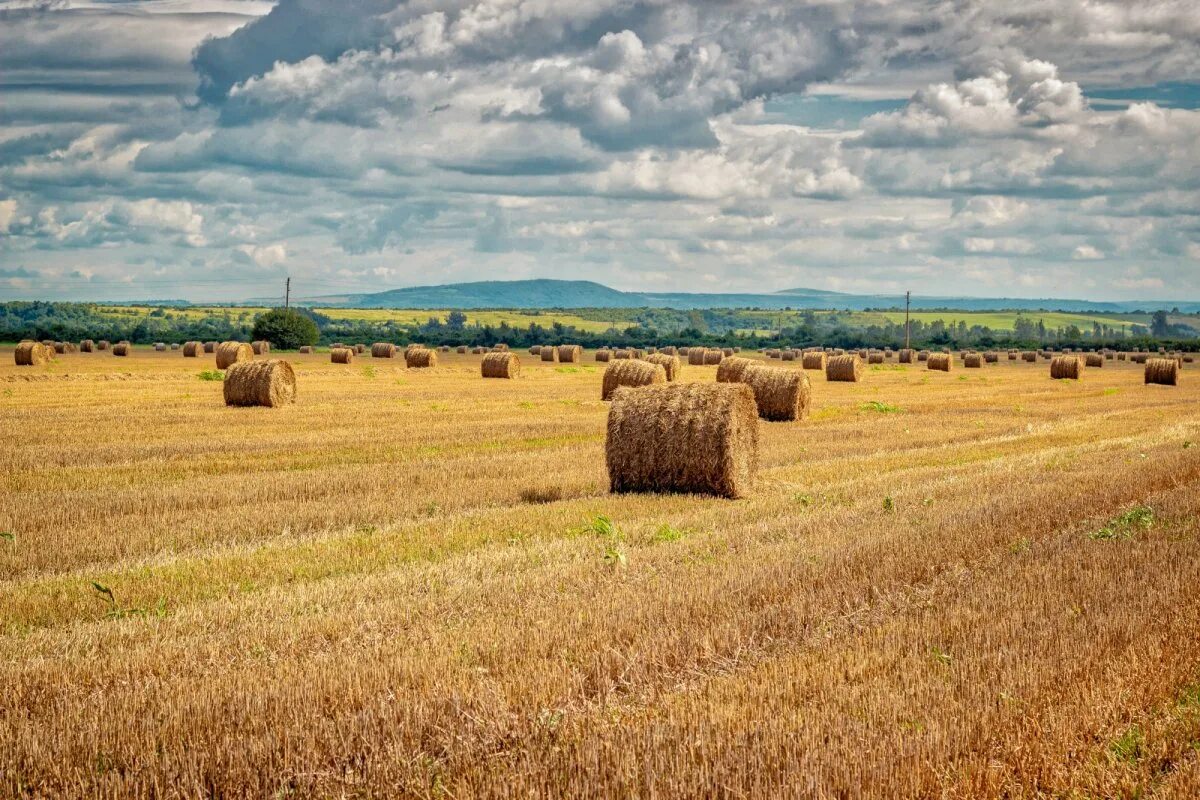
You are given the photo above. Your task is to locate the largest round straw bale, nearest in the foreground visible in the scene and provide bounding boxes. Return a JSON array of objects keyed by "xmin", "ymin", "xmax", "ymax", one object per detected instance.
[{"xmin": 605, "ymin": 384, "xmax": 758, "ymax": 498}]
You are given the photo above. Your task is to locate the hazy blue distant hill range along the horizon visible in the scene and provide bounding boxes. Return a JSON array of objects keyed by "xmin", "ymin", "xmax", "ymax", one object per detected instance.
[{"xmin": 265, "ymin": 278, "xmax": 1200, "ymax": 313}]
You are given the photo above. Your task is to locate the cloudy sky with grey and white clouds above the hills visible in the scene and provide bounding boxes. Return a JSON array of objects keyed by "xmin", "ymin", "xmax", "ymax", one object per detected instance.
[{"xmin": 0, "ymin": 0, "xmax": 1200, "ymax": 301}]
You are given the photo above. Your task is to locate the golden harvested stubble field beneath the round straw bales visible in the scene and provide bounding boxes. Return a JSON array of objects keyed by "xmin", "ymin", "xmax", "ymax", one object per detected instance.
[{"xmin": 0, "ymin": 347, "xmax": 1200, "ymax": 799}]
